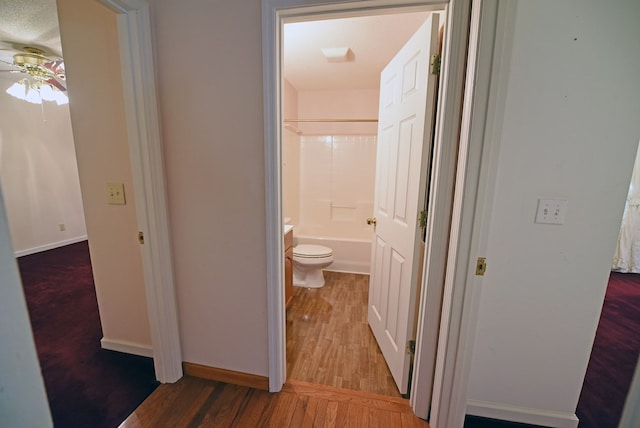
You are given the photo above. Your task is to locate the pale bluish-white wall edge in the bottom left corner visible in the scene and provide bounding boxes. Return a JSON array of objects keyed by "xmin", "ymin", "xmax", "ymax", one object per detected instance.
[{"xmin": 0, "ymin": 194, "xmax": 53, "ymax": 428}]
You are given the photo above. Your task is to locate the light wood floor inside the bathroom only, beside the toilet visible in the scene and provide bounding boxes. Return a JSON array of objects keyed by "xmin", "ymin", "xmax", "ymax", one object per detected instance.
[{"xmin": 287, "ymin": 272, "xmax": 400, "ymax": 397}]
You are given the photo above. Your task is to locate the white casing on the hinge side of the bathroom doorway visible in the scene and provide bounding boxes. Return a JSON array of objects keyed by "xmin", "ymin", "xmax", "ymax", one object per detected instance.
[{"xmin": 410, "ymin": 1, "xmax": 473, "ymax": 416}]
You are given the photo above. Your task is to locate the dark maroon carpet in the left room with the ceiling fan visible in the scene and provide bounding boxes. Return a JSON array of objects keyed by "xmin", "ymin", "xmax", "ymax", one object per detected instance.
[{"xmin": 18, "ymin": 241, "xmax": 158, "ymax": 428}]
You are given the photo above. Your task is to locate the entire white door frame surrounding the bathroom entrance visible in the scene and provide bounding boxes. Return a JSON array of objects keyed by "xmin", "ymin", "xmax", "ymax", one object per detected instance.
[{"xmin": 262, "ymin": 0, "xmax": 508, "ymax": 422}]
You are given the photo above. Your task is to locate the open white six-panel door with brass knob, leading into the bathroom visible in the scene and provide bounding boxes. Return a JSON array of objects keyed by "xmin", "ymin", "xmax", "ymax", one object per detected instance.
[{"xmin": 368, "ymin": 14, "xmax": 438, "ymax": 394}]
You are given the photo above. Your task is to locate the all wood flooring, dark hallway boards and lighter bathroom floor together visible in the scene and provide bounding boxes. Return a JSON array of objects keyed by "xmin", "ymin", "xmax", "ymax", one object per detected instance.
[{"xmin": 121, "ymin": 272, "xmax": 429, "ymax": 428}]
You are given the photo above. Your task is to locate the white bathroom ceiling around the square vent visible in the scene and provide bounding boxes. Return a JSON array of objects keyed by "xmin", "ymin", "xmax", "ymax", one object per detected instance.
[{"xmin": 283, "ymin": 12, "xmax": 428, "ymax": 91}]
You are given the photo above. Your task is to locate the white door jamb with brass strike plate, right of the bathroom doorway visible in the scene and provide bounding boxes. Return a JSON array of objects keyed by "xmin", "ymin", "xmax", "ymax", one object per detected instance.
[{"xmin": 430, "ymin": 0, "xmax": 516, "ymax": 428}]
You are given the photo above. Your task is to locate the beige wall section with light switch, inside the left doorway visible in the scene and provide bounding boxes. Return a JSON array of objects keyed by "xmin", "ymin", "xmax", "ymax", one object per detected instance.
[{"xmin": 57, "ymin": 0, "xmax": 153, "ymax": 355}]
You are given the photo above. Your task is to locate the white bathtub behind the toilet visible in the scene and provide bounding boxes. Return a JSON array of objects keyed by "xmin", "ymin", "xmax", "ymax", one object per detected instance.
[{"xmin": 293, "ymin": 234, "xmax": 371, "ymax": 275}]
